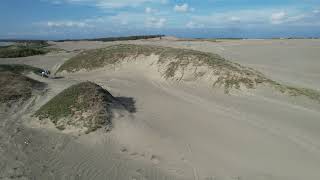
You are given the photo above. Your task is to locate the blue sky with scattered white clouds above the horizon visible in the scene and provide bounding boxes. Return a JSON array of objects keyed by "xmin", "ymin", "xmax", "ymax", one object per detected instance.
[{"xmin": 0, "ymin": 0, "xmax": 320, "ymax": 39}]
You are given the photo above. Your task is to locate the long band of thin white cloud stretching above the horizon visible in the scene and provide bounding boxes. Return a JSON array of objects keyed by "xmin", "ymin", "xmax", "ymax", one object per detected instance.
[{"xmin": 36, "ymin": 6, "xmax": 320, "ymax": 32}]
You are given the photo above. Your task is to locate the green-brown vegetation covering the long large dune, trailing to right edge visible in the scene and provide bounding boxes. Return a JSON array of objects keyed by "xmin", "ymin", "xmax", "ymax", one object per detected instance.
[{"xmin": 58, "ymin": 44, "xmax": 320, "ymax": 102}]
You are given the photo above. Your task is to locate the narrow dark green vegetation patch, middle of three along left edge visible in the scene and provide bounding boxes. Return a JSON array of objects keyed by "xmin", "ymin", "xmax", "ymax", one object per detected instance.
[{"xmin": 0, "ymin": 64, "xmax": 43, "ymax": 75}]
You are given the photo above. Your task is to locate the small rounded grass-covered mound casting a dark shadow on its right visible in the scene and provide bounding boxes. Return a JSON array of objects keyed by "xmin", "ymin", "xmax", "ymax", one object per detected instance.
[{"xmin": 35, "ymin": 82, "xmax": 115, "ymax": 133}]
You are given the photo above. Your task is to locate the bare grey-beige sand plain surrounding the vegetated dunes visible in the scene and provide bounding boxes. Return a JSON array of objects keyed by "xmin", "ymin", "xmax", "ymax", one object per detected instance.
[{"xmin": 0, "ymin": 38, "xmax": 320, "ymax": 180}]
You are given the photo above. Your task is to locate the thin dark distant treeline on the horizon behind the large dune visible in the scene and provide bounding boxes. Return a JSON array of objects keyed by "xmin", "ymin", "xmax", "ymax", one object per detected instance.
[{"xmin": 55, "ymin": 35, "xmax": 165, "ymax": 42}]
